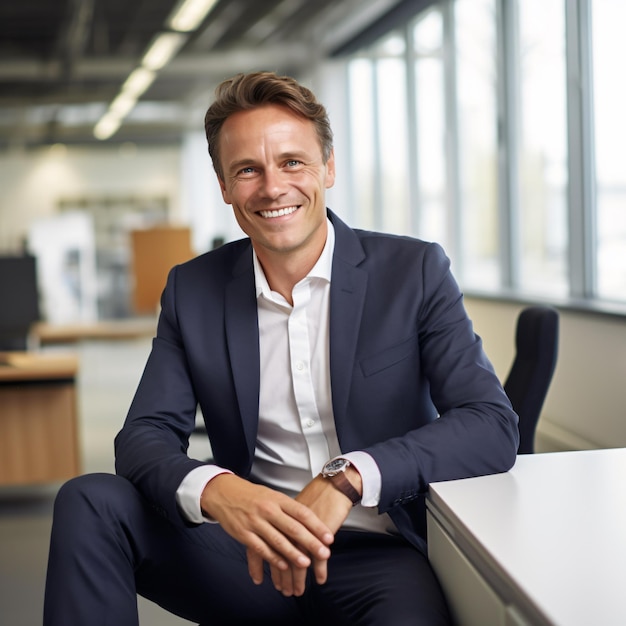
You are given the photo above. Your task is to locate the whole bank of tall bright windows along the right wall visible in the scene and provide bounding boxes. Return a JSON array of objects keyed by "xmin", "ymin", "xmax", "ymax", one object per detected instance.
[{"xmin": 342, "ymin": 0, "xmax": 626, "ymax": 310}]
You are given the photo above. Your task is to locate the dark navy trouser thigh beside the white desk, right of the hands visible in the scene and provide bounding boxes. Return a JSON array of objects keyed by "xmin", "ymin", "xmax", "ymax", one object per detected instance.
[{"xmin": 310, "ymin": 531, "xmax": 451, "ymax": 626}]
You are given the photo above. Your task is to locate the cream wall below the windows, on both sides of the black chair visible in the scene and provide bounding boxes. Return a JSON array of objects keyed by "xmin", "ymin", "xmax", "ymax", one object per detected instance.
[{"xmin": 466, "ymin": 298, "xmax": 626, "ymax": 451}]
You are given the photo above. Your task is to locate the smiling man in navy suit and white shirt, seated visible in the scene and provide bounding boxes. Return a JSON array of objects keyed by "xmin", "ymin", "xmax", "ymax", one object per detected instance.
[{"xmin": 44, "ymin": 73, "xmax": 518, "ymax": 626}]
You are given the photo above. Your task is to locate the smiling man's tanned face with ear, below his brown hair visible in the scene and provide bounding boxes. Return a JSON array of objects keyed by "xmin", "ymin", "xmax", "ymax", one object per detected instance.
[{"xmin": 219, "ymin": 105, "xmax": 335, "ymax": 261}]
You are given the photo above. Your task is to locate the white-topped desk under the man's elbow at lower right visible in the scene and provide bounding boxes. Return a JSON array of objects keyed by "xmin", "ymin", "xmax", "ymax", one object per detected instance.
[{"xmin": 427, "ymin": 449, "xmax": 626, "ymax": 626}]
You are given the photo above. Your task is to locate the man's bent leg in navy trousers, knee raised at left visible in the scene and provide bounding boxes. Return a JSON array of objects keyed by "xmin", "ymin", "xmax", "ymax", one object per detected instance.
[{"xmin": 46, "ymin": 474, "xmax": 306, "ymax": 626}]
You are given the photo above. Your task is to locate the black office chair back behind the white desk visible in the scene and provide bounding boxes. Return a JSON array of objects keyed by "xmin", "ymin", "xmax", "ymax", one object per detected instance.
[{"xmin": 504, "ymin": 306, "xmax": 559, "ymax": 454}]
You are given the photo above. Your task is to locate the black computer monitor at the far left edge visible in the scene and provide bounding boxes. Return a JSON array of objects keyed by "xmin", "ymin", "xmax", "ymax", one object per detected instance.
[{"xmin": 0, "ymin": 255, "xmax": 40, "ymax": 350}]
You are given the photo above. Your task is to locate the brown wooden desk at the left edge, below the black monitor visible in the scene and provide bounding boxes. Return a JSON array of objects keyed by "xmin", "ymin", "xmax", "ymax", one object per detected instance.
[{"xmin": 0, "ymin": 352, "xmax": 80, "ymax": 485}]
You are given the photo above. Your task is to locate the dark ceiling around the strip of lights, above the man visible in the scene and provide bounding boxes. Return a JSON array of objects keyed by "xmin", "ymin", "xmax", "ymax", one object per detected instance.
[{"xmin": 0, "ymin": 0, "xmax": 398, "ymax": 148}]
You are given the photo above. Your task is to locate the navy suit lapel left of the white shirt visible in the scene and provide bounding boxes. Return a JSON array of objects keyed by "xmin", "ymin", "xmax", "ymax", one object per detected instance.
[{"xmin": 225, "ymin": 246, "xmax": 260, "ymax": 473}]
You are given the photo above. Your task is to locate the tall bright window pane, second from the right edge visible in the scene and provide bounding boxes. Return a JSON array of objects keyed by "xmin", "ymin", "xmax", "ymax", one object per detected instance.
[{"xmin": 516, "ymin": 0, "xmax": 568, "ymax": 296}]
